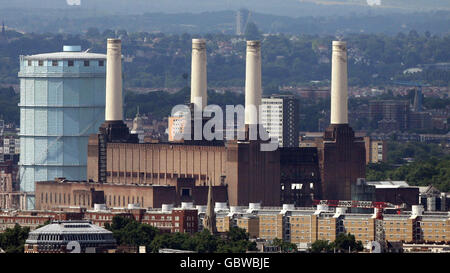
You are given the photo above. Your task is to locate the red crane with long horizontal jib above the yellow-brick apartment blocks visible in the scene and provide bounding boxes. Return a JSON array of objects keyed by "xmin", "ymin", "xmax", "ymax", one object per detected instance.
[{"xmin": 313, "ymin": 200, "xmax": 406, "ymax": 219}]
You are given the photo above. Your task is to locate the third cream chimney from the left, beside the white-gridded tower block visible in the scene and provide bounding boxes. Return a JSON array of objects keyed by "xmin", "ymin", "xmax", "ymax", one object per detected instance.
[{"xmin": 245, "ymin": 41, "xmax": 262, "ymax": 124}]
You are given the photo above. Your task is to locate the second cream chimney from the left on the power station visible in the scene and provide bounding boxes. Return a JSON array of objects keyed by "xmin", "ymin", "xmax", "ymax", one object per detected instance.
[{"xmin": 191, "ymin": 39, "xmax": 207, "ymax": 109}]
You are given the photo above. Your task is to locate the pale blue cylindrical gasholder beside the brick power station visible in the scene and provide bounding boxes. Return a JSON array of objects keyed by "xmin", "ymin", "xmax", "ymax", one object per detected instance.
[{"xmin": 19, "ymin": 46, "xmax": 106, "ymax": 209}]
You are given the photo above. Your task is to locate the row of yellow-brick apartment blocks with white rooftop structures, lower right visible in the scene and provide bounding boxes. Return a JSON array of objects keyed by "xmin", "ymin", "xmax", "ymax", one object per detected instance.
[{"xmin": 199, "ymin": 204, "xmax": 450, "ymax": 250}]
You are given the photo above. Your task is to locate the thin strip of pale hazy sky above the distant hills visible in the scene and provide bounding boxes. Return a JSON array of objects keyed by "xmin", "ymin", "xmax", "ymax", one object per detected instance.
[{"xmin": 0, "ymin": 0, "xmax": 450, "ymax": 17}]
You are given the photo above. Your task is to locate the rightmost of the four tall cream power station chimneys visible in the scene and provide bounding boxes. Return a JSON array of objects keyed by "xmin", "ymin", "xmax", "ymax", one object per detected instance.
[{"xmin": 330, "ymin": 41, "xmax": 348, "ymax": 124}]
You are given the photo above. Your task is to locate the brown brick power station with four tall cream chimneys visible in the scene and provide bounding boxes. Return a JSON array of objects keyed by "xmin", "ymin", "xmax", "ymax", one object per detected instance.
[{"xmin": 35, "ymin": 39, "xmax": 365, "ymax": 210}]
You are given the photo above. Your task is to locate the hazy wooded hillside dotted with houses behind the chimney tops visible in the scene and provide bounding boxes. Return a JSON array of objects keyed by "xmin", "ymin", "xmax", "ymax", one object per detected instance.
[{"xmin": 0, "ymin": 29, "xmax": 450, "ymax": 88}]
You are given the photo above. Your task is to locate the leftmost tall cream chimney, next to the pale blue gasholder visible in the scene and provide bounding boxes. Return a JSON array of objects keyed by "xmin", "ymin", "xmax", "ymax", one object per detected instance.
[{"xmin": 105, "ymin": 39, "xmax": 123, "ymax": 121}]
